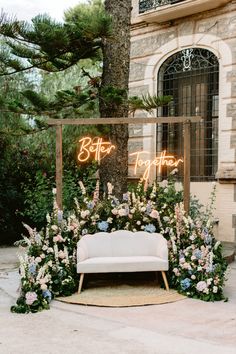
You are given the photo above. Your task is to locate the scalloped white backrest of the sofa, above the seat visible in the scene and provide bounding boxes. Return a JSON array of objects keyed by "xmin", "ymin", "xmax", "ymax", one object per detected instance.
[{"xmin": 78, "ymin": 230, "xmax": 168, "ymax": 261}]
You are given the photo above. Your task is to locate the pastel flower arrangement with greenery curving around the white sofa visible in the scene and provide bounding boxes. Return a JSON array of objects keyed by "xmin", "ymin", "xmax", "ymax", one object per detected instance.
[{"xmin": 12, "ymin": 180, "xmax": 227, "ymax": 312}]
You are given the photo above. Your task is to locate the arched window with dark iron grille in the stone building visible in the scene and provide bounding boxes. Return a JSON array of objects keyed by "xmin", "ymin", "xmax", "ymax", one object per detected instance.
[{"xmin": 157, "ymin": 48, "xmax": 219, "ymax": 181}]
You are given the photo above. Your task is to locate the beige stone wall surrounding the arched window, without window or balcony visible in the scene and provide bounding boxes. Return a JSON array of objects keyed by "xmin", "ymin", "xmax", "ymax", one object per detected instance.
[{"xmin": 129, "ymin": 0, "xmax": 236, "ymax": 242}]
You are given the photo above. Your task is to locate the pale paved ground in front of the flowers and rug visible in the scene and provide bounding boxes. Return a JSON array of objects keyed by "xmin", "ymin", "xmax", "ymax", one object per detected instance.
[{"xmin": 0, "ymin": 248, "xmax": 236, "ymax": 354}]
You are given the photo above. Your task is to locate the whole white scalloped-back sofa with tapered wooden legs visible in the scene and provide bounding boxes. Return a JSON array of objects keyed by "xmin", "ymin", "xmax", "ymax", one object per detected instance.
[{"xmin": 77, "ymin": 230, "xmax": 169, "ymax": 293}]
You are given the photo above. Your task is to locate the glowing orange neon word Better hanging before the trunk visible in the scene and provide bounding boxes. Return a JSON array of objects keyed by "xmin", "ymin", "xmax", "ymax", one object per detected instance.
[{"xmin": 78, "ymin": 136, "xmax": 115, "ymax": 162}]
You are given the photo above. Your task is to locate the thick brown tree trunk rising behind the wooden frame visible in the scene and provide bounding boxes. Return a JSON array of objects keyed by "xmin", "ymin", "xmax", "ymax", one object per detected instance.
[{"xmin": 99, "ymin": 0, "xmax": 131, "ymax": 198}]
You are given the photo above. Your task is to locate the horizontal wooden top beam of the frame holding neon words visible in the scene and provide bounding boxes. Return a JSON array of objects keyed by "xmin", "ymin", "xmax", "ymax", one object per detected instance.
[{"xmin": 47, "ymin": 116, "xmax": 202, "ymax": 125}]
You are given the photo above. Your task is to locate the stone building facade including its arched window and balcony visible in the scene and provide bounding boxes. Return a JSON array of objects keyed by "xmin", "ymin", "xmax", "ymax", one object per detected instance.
[{"xmin": 129, "ymin": 0, "xmax": 236, "ymax": 242}]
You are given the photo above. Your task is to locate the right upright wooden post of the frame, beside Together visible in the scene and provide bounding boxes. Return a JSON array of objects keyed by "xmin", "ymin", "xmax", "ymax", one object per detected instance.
[{"xmin": 184, "ymin": 120, "xmax": 190, "ymax": 214}]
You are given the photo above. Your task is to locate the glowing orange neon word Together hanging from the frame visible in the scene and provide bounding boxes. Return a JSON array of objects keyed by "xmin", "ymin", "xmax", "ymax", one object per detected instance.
[{"xmin": 129, "ymin": 150, "xmax": 184, "ymax": 181}]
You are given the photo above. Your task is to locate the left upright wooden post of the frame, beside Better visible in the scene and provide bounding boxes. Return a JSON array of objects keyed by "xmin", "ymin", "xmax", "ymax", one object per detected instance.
[{"xmin": 56, "ymin": 125, "xmax": 62, "ymax": 210}]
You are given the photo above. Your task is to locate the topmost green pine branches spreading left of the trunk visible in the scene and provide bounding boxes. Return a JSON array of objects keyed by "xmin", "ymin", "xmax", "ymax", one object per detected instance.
[{"xmin": 0, "ymin": 6, "xmax": 111, "ymax": 76}]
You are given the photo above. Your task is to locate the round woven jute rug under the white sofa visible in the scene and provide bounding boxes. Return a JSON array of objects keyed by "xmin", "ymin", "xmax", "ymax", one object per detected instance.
[{"xmin": 56, "ymin": 283, "xmax": 185, "ymax": 307}]
